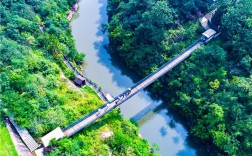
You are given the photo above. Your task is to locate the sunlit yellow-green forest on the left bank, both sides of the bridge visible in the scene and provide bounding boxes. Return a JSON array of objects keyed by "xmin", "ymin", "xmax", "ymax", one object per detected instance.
[{"xmin": 0, "ymin": 0, "xmax": 158, "ymax": 155}]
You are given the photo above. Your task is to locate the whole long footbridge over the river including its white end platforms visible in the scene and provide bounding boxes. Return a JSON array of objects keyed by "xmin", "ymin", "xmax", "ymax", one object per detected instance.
[{"xmin": 41, "ymin": 29, "xmax": 219, "ymax": 147}]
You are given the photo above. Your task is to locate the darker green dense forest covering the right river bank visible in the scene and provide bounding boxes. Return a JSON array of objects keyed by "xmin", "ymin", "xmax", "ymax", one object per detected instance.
[{"xmin": 107, "ymin": 0, "xmax": 252, "ymax": 155}]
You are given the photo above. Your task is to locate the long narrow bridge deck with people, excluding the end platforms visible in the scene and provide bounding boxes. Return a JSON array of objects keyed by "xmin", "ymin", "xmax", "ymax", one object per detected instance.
[{"xmin": 63, "ymin": 40, "xmax": 202, "ymax": 137}]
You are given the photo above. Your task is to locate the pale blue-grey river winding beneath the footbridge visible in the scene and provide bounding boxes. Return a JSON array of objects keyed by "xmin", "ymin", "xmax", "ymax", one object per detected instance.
[{"xmin": 71, "ymin": 0, "xmax": 206, "ymax": 156}]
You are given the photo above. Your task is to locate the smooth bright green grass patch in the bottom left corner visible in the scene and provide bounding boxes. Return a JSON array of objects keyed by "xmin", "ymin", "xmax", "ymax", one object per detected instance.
[{"xmin": 0, "ymin": 120, "xmax": 18, "ymax": 156}]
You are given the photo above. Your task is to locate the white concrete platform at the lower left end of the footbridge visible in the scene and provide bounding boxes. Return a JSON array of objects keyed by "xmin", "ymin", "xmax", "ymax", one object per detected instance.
[{"xmin": 41, "ymin": 127, "xmax": 64, "ymax": 147}]
